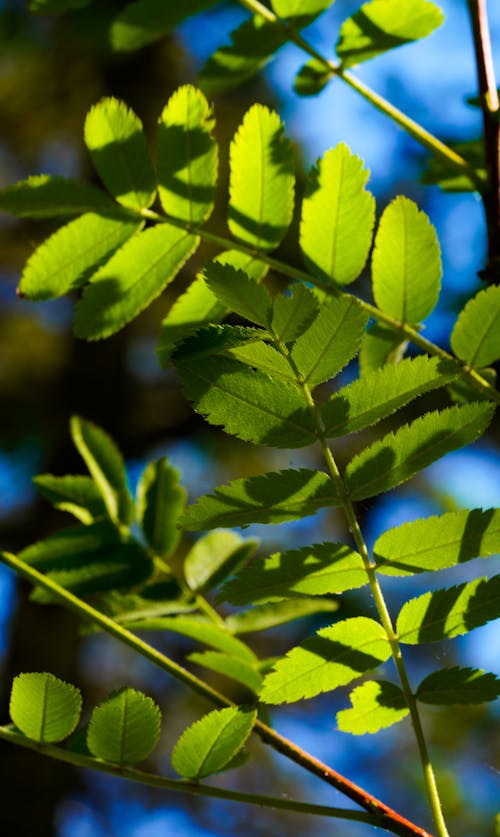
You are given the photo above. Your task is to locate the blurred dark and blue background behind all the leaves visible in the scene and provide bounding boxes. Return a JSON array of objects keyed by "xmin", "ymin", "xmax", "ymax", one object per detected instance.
[{"xmin": 0, "ymin": 0, "xmax": 500, "ymax": 837}]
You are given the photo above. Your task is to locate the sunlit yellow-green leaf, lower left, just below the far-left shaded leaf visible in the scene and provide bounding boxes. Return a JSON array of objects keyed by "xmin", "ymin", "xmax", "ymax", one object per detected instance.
[{"xmin": 19, "ymin": 212, "xmax": 142, "ymax": 300}]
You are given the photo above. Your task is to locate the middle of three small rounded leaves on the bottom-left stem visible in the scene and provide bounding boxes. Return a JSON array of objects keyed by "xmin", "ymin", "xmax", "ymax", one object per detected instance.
[{"xmin": 87, "ymin": 688, "xmax": 161, "ymax": 765}]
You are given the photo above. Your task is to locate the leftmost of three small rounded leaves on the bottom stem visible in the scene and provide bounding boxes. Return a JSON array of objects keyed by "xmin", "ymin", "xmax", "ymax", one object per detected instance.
[{"xmin": 9, "ymin": 672, "xmax": 82, "ymax": 744}]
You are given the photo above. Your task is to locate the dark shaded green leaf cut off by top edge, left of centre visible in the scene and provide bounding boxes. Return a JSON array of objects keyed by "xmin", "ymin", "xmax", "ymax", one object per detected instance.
[{"xmin": 111, "ymin": 0, "xmax": 217, "ymax": 52}]
